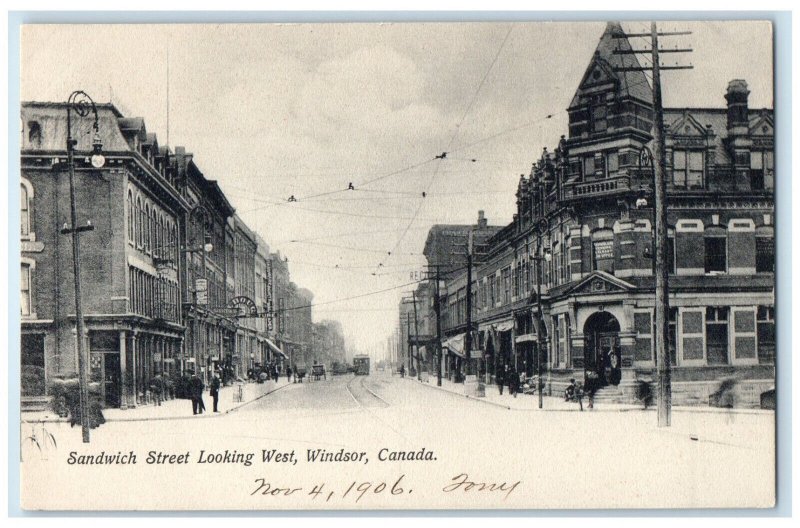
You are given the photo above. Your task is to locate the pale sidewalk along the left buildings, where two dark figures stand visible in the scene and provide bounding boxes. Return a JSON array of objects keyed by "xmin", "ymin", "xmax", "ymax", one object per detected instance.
[{"xmin": 22, "ymin": 377, "xmax": 290, "ymax": 422}]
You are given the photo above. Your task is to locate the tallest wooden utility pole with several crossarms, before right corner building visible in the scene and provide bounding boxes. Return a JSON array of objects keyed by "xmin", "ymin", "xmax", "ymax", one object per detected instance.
[{"xmin": 615, "ymin": 22, "xmax": 692, "ymax": 427}]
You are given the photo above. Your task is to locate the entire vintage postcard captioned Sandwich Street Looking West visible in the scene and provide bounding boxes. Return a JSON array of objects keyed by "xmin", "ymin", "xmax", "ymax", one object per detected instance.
[{"xmin": 19, "ymin": 21, "xmax": 788, "ymax": 510}]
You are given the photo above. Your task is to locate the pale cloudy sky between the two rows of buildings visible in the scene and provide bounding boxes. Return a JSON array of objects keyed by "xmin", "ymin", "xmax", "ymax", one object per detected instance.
[{"xmin": 21, "ymin": 22, "xmax": 773, "ymax": 355}]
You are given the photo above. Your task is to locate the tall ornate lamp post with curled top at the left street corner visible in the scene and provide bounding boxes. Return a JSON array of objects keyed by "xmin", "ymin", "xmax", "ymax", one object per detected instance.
[{"xmin": 61, "ymin": 90, "xmax": 106, "ymax": 443}]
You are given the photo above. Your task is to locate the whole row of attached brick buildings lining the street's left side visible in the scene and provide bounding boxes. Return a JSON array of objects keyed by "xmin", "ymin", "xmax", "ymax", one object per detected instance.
[{"xmin": 20, "ymin": 102, "xmax": 313, "ymax": 408}]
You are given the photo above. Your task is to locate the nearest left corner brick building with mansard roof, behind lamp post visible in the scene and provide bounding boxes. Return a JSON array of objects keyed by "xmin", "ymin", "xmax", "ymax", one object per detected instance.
[{"xmin": 20, "ymin": 103, "xmax": 190, "ymax": 407}]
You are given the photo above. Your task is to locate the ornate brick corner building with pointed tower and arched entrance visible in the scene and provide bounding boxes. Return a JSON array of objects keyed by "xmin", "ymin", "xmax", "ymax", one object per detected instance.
[{"xmin": 434, "ymin": 23, "xmax": 775, "ymax": 405}]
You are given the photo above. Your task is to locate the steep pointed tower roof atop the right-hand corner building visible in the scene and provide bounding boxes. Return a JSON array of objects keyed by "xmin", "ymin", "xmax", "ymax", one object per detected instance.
[{"xmin": 569, "ymin": 22, "xmax": 653, "ymax": 108}]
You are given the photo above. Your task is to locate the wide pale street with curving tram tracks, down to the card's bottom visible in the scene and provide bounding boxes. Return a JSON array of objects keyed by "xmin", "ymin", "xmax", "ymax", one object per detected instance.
[{"xmin": 23, "ymin": 372, "xmax": 774, "ymax": 508}]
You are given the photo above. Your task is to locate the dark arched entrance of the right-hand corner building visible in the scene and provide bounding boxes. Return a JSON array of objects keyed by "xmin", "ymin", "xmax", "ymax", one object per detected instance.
[{"xmin": 583, "ymin": 312, "xmax": 622, "ymax": 386}]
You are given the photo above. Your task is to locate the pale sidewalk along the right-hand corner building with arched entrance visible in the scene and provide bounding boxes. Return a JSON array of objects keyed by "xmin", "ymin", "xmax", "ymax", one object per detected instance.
[{"xmin": 408, "ymin": 376, "xmax": 774, "ymax": 414}]
